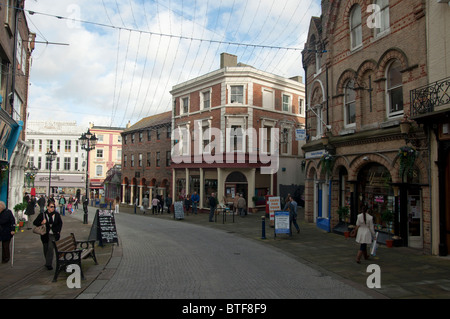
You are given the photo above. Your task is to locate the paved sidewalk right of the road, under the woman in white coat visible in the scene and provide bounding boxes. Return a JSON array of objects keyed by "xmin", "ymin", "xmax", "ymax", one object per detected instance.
[{"xmin": 117, "ymin": 207, "xmax": 450, "ymax": 299}]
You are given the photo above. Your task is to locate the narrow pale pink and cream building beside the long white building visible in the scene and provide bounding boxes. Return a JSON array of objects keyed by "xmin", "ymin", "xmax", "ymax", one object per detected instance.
[{"xmin": 88, "ymin": 123, "xmax": 124, "ymax": 199}]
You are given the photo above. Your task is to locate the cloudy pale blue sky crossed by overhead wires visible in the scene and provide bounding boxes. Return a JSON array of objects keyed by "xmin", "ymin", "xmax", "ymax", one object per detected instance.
[{"xmin": 25, "ymin": 0, "xmax": 320, "ymax": 127}]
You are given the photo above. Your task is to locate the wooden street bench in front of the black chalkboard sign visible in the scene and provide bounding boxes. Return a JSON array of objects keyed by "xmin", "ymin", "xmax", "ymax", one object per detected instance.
[{"xmin": 53, "ymin": 233, "xmax": 98, "ymax": 282}]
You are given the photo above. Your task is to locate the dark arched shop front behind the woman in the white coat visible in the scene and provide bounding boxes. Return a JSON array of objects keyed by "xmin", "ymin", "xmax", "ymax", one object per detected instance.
[{"xmin": 348, "ymin": 163, "xmax": 424, "ymax": 248}]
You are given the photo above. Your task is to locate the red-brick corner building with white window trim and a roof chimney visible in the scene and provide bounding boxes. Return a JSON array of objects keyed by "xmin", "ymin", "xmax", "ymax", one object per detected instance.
[{"xmin": 171, "ymin": 53, "xmax": 305, "ymax": 209}]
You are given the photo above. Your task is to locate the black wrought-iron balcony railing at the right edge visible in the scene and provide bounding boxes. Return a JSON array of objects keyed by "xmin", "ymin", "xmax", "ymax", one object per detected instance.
[{"xmin": 411, "ymin": 77, "xmax": 450, "ymax": 117}]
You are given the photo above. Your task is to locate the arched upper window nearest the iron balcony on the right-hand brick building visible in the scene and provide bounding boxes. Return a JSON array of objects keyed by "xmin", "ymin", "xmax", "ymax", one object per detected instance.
[{"xmin": 386, "ymin": 60, "xmax": 403, "ymax": 116}]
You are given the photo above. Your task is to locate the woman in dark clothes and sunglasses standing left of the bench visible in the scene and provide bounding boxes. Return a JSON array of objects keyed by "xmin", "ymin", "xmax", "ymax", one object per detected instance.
[{"xmin": 33, "ymin": 201, "xmax": 63, "ymax": 270}]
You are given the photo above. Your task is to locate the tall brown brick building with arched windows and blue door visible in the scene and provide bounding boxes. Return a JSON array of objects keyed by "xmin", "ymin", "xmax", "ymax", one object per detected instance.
[{"xmin": 303, "ymin": 0, "xmax": 431, "ymax": 252}]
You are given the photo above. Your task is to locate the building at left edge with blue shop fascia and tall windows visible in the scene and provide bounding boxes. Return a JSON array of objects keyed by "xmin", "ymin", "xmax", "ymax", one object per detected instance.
[{"xmin": 0, "ymin": 0, "xmax": 35, "ymax": 207}]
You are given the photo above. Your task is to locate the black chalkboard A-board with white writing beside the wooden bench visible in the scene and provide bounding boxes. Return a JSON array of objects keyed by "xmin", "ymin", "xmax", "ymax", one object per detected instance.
[{"xmin": 89, "ymin": 209, "xmax": 119, "ymax": 246}]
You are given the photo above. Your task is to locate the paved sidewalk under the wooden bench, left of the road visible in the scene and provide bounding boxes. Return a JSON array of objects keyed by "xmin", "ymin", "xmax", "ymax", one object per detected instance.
[{"xmin": 0, "ymin": 207, "xmax": 115, "ymax": 299}]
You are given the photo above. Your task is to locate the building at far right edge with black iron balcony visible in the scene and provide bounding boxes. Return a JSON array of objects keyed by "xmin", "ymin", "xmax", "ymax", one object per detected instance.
[{"xmin": 408, "ymin": 1, "xmax": 450, "ymax": 256}]
